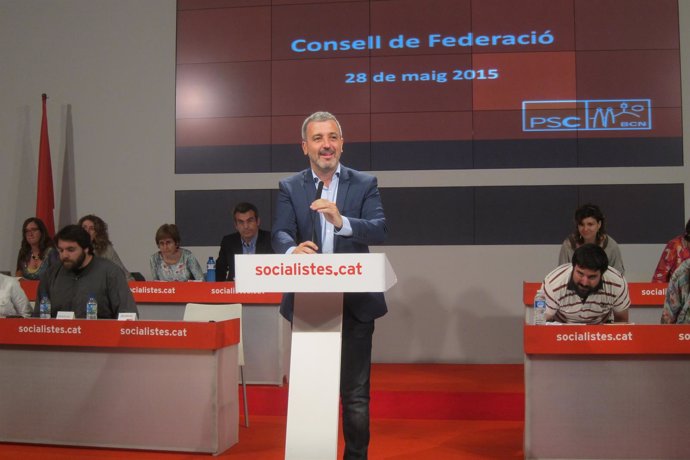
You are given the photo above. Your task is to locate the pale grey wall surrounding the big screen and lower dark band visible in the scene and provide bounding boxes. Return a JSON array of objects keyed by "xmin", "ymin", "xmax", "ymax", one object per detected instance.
[{"xmin": 0, "ymin": 0, "xmax": 690, "ymax": 362}]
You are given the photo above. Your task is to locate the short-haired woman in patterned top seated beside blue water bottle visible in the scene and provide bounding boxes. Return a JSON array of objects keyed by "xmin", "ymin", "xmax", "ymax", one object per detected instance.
[{"xmin": 150, "ymin": 224, "xmax": 204, "ymax": 281}]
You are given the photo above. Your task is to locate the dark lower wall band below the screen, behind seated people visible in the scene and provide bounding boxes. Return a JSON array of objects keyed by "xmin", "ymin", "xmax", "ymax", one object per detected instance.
[{"xmin": 175, "ymin": 184, "xmax": 685, "ymax": 246}]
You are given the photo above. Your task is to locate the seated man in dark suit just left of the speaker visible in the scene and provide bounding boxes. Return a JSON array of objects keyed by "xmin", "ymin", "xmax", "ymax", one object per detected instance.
[{"xmin": 216, "ymin": 203, "xmax": 273, "ymax": 281}]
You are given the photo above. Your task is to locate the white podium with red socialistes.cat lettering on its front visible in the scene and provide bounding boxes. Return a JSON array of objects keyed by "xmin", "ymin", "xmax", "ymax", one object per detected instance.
[{"xmin": 235, "ymin": 254, "xmax": 397, "ymax": 460}]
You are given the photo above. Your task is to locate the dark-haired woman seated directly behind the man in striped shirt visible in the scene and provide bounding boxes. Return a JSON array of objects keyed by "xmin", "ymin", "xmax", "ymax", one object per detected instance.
[{"xmin": 558, "ymin": 203, "xmax": 625, "ymax": 275}]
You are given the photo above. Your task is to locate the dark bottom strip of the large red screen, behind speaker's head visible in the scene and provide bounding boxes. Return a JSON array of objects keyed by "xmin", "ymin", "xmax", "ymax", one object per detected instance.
[{"xmin": 175, "ymin": 137, "xmax": 683, "ymax": 174}]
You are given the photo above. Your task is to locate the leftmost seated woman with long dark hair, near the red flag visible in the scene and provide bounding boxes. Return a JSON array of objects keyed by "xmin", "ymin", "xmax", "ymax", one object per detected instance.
[{"xmin": 15, "ymin": 217, "xmax": 57, "ymax": 280}]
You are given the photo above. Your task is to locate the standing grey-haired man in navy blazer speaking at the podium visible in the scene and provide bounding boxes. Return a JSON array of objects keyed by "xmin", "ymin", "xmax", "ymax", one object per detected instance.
[{"xmin": 272, "ymin": 112, "xmax": 387, "ymax": 460}]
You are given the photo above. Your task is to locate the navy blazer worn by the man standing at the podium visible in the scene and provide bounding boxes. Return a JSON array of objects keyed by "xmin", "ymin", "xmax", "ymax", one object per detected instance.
[{"xmin": 272, "ymin": 165, "xmax": 388, "ymax": 321}]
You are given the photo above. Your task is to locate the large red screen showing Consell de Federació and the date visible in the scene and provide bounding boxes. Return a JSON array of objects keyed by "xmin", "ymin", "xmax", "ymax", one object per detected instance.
[{"xmin": 175, "ymin": 0, "xmax": 683, "ymax": 174}]
